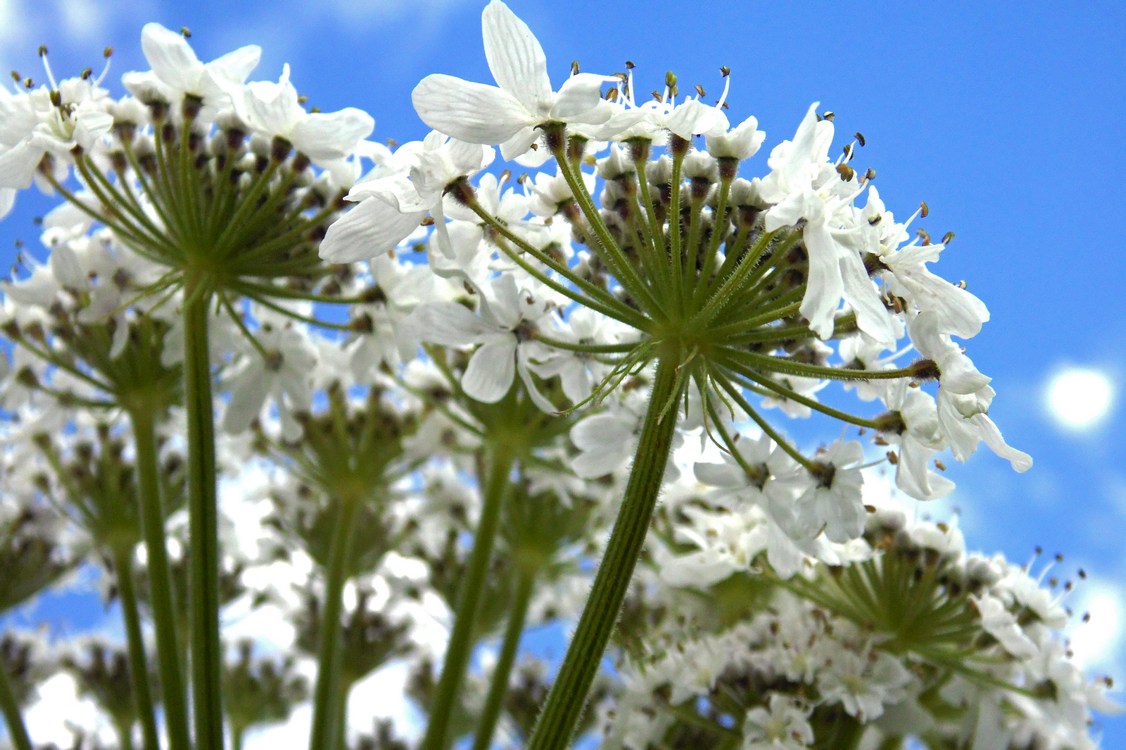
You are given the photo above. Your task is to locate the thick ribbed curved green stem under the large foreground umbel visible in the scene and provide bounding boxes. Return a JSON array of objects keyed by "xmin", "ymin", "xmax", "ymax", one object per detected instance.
[{"xmin": 528, "ymin": 356, "xmax": 683, "ymax": 750}]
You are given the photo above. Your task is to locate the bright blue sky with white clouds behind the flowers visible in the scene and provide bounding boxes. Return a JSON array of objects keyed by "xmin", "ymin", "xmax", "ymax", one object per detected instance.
[{"xmin": 0, "ymin": 0, "xmax": 1126, "ymax": 748}]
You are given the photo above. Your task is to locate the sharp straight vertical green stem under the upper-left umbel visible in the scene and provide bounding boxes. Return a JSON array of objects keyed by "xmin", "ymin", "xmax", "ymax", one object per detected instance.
[{"xmin": 181, "ymin": 276, "xmax": 223, "ymax": 750}]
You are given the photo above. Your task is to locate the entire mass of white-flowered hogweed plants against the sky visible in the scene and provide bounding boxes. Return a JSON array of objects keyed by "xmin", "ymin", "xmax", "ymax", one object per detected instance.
[{"xmin": 0, "ymin": 0, "xmax": 1115, "ymax": 750}]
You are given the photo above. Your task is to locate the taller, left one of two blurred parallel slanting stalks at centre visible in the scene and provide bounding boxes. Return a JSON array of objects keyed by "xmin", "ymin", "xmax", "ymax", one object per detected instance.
[{"xmin": 421, "ymin": 440, "xmax": 515, "ymax": 750}]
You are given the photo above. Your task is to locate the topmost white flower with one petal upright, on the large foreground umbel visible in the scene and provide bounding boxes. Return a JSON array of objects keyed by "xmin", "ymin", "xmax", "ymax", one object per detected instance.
[{"xmin": 411, "ymin": 0, "xmax": 615, "ymax": 159}]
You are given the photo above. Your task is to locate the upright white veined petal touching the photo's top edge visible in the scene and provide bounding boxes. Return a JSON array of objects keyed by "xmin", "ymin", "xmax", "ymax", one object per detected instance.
[{"xmin": 484, "ymin": 0, "xmax": 552, "ymax": 110}]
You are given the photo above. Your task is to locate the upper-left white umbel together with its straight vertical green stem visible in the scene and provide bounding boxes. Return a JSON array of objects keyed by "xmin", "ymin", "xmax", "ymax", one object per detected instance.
[{"xmin": 2, "ymin": 24, "xmax": 379, "ymax": 748}]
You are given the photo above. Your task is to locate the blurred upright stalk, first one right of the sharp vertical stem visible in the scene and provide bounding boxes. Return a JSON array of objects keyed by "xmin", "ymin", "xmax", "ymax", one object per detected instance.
[{"xmin": 309, "ymin": 495, "xmax": 360, "ymax": 750}]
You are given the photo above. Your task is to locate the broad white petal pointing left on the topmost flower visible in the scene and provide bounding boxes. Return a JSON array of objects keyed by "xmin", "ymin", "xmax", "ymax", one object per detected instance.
[{"xmin": 411, "ymin": 73, "xmax": 536, "ymax": 145}]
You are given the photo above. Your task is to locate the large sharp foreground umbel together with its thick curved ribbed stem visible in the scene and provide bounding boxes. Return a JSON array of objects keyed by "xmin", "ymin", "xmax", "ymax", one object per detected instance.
[{"xmin": 321, "ymin": 0, "xmax": 1031, "ymax": 748}]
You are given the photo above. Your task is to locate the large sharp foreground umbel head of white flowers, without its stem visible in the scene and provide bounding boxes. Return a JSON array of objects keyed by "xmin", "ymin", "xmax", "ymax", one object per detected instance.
[{"xmin": 321, "ymin": 2, "xmax": 1031, "ymax": 560}]
